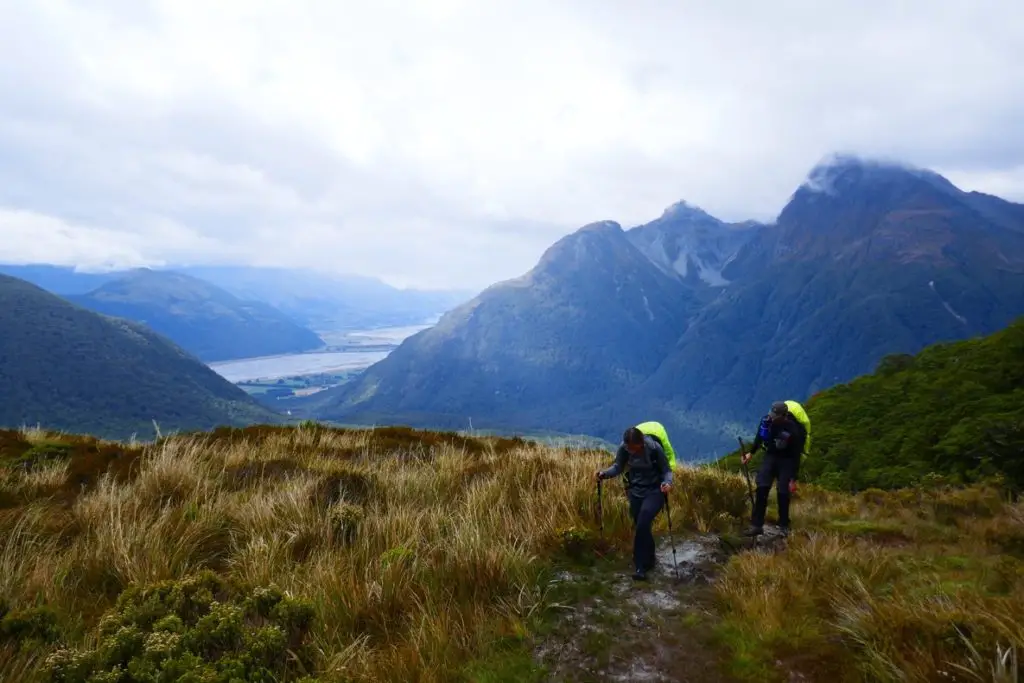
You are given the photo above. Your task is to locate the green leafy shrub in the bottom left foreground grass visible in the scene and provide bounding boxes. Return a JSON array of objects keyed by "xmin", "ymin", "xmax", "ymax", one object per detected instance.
[{"xmin": 46, "ymin": 571, "xmax": 315, "ymax": 683}]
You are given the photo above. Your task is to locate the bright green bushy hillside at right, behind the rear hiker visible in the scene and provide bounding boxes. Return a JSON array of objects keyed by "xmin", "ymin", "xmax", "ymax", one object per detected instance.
[{"xmin": 724, "ymin": 317, "xmax": 1024, "ymax": 490}]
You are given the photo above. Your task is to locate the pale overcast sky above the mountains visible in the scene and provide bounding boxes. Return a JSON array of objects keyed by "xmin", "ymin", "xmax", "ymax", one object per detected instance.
[{"xmin": 0, "ymin": 0, "xmax": 1024, "ymax": 288}]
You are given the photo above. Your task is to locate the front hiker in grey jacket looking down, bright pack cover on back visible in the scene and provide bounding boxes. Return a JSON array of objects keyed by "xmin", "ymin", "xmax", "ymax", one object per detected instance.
[{"xmin": 596, "ymin": 427, "xmax": 672, "ymax": 581}]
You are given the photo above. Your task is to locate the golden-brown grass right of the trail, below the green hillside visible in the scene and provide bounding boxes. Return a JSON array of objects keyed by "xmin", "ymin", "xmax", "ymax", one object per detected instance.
[{"xmin": 717, "ymin": 485, "xmax": 1024, "ymax": 681}]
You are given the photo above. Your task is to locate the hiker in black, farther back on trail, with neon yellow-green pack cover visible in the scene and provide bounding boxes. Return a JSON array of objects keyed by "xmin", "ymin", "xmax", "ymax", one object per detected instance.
[{"xmin": 742, "ymin": 400, "xmax": 807, "ymax": 536}]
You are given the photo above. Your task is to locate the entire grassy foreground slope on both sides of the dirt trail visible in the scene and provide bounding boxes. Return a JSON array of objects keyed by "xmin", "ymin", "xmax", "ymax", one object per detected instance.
[{"xmin": 0, "ymin": 426, "xmax": 1024, "ymax": 681}]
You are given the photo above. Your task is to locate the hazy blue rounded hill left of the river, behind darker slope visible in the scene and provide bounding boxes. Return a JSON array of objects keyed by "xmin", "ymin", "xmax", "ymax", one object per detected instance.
[{"xmin": 66, "ymin": 268, "xmax": 325, "ymax": 362}]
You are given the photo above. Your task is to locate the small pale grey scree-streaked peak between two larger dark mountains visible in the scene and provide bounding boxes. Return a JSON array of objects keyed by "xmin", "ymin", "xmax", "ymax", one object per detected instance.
[{"xmin": 627, "ymin": 202, "xmax": 761, "ymax": 287}]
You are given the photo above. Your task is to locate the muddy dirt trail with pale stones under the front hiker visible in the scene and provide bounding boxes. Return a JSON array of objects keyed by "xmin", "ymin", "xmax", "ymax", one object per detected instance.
[{"xmin": 535, "ymin": 528, "xmax": 780, "ymax": 683}]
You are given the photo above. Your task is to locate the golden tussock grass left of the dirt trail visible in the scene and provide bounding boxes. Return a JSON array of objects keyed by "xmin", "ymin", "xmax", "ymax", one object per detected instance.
[{"xmin": 0, "ymin": 425, "xmax": 630, "ymax": 681}]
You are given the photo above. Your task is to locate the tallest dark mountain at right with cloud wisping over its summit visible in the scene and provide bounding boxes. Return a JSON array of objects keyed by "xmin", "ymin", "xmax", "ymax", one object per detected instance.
[{"xmin": 636, "ymin": 158, "xmax": 1024, "ymax": 445}]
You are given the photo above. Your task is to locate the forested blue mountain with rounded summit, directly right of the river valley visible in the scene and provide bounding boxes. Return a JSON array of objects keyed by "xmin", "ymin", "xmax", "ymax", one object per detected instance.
[{"xmin": 321, "ymin": 221, "xmax": 703, "ymax": 433}]
